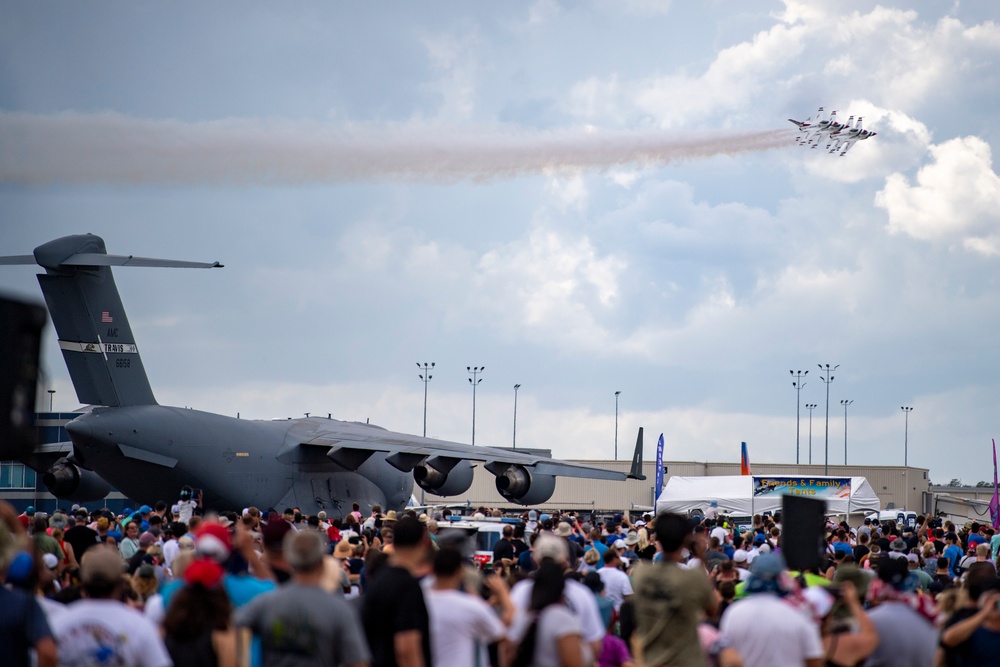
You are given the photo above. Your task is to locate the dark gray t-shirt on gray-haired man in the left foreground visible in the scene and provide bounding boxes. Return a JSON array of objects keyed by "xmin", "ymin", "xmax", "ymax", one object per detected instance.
[{"xmin": 235, "ymin": 582, "xmax": 370, "ymax": 667}]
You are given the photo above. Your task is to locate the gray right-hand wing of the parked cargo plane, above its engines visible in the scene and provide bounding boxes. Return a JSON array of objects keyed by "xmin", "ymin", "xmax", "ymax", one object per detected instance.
[{"xmin": 279, "ymin": 418, "xmax": 642, "ymax": 481}]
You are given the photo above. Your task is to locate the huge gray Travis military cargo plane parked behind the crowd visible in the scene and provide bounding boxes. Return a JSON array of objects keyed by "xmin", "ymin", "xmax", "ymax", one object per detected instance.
[{"xmin": 0, "ymin": 234, "xmax": 645, "ymax": 516}]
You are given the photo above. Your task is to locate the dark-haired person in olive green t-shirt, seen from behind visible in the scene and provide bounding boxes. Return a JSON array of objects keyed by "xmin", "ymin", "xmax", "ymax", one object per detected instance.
[{"xmin": 632, "ymin": 513, "xmax": 717, "ymax": 667}]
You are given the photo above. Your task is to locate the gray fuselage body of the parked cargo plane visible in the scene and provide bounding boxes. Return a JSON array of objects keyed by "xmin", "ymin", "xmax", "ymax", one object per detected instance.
[{"xmin": 66, "ymin": 405, "xmax": 413, "ymax": 516}]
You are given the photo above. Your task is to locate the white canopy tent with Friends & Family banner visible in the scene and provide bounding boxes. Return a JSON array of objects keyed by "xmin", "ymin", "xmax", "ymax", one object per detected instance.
[{"xmin": 656, "ymin": 475, "xmax": 882, "ymax": 515}]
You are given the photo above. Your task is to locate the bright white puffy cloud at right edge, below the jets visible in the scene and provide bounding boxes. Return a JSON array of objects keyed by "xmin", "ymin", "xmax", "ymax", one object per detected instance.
[{"xmin": 875, "ymin": 136, "xmax": 1000, "ymax": 256}]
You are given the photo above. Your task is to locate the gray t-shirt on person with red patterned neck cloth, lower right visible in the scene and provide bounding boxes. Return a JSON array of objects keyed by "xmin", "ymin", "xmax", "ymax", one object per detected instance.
[{"xmin": 865, "ymin": 602, "xmax": 938, "ymax": 667}]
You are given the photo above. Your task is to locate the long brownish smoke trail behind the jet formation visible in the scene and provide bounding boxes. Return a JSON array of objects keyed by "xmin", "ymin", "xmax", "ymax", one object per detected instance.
[{"xmin": 0, "ymin": 113, "xmax": 792, "ymax": 185}]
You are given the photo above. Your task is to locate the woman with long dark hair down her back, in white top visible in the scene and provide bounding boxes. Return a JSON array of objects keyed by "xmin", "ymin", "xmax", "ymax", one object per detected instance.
[{"xmin": 511, "ymin": 564, "xmax": 588, "ymax": 667}]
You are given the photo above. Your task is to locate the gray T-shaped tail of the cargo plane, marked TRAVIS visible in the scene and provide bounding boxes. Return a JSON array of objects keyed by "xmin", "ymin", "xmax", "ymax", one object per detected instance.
[{"xmin": 0, "ymin": 234, "xmax": 221, "ymax": 407}]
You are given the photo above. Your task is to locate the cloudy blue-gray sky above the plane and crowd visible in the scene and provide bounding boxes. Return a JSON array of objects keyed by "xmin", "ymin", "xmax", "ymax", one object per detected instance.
[{"xmin": 0, "ymin": 0, "xmax": 1000, "ymax": 484}]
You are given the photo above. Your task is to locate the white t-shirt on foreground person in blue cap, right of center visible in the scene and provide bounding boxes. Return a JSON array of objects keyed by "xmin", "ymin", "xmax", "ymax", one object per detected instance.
[{"xmin": 719, "ymin": 593, "xmax": 824, "ymax": 667}]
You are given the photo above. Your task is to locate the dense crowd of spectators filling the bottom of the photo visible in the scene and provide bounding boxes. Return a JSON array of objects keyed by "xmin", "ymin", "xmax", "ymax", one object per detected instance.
[{"xmin": 0, "ymin": 487, "xmax": 1000, "ymax": 667}]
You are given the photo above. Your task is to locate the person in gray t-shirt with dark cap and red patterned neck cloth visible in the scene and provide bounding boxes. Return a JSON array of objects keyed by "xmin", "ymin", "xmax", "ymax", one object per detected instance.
[{"xmin": 866, "ymin": 556, "xmax": 937, "ymax": 667}]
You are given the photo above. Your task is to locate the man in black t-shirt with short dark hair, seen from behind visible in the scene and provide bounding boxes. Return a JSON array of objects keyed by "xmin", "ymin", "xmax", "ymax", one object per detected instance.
[{"xmin": 361, "ymin": 517, "xmax": 433, "ymax": 667}]
